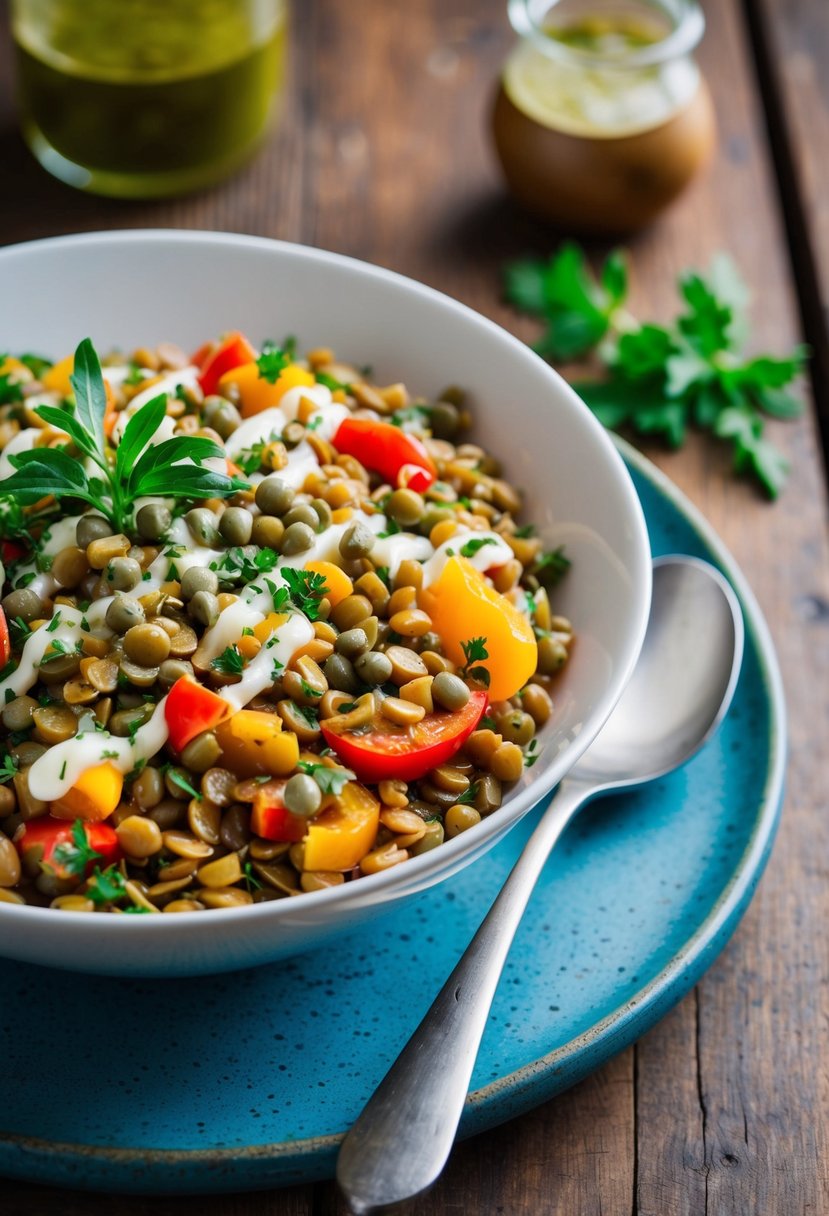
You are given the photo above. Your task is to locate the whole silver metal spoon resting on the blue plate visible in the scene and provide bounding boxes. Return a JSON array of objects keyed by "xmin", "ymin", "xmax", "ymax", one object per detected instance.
[{"xmin": 337, "ymin": 557, "xmax": 743, "ymax": 1216}]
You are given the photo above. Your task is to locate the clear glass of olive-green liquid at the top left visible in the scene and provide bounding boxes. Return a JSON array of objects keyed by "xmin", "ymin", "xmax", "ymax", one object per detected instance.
[{"xmin": 11, "ymin": 0, "xmax": 286, "ymax": 198}]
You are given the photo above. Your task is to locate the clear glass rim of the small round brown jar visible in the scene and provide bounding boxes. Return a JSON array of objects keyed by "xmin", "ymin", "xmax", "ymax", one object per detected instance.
[{"xmin": 507, "ymin": 0, "xmax": 705, "ymax": 71}]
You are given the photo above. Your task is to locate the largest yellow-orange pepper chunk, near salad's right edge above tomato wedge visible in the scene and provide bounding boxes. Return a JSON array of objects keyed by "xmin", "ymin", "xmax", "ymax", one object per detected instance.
[{"xmin": 418, "ymin": 557, "xmax": 538, "ymax": 700}]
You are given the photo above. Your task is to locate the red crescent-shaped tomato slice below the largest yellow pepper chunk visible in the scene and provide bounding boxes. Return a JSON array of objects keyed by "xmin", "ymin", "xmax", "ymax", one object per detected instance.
[{"xmin": 320, "ymin": 692, "xmax": 489, "ymax": 782}]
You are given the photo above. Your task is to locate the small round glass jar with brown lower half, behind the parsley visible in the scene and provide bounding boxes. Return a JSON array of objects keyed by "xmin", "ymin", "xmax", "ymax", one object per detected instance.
[{"xmin": 492, "ymin": 0, "xmax": 715, "ymax": 233}]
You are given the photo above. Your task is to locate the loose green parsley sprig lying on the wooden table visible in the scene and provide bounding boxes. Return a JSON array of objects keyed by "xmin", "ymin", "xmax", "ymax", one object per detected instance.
[{"xmin": 504, "ymin": 243, "xmax": 807, "ymax": 499}]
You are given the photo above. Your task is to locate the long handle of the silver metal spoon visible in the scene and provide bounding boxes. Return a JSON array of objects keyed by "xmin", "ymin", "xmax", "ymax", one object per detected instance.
[{"xmin": 337, "ymin": 778, "xmax": 596, "ymax": 1216}]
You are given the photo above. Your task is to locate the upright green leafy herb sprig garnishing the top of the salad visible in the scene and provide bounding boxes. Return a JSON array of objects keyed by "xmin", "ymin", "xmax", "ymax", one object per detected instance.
[{"xmin": 0, "ymin": 338, "xmax": 247, "ymax": 531}]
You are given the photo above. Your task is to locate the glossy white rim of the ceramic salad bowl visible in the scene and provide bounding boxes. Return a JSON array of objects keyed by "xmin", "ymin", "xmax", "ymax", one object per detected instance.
[{"xmin": 0, "ymin": 227, "xmax": 652, "ymax": 938}]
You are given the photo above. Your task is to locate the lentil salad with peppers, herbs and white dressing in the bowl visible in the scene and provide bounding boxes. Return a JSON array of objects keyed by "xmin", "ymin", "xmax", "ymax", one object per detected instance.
[{"xmin": 0, "ymin": 333, "xmax": 573, "ymax": 913}]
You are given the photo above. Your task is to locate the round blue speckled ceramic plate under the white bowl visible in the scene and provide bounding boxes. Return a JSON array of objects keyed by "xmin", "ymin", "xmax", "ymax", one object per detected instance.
[{"xmin": 0, "ymin": 447, "xmax": 785, "ymax": 1193}]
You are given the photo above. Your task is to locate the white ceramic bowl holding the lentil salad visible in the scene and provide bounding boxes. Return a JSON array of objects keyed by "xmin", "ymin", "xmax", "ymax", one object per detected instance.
[{"xmin": 0, "ymin": 231, "xmax": 650, "ymax": 975}]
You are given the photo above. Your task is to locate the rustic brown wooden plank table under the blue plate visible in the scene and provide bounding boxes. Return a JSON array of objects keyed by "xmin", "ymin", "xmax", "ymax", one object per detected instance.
[{"xmin": 0, "ymin": 0, "xmax": 829, "ymax": 1216}]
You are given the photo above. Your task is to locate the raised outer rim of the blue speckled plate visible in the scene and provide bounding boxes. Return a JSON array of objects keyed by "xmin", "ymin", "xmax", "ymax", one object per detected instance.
[{"xmin": 0, "ymin": 437, "xmax": 786, "ymax": 1193}]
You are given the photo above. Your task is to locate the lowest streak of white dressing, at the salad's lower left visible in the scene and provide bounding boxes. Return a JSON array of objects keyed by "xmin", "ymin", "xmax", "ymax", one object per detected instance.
[{"xmin": 29, "ymin": 697, "xmax": 169, "ymax": 803}]
